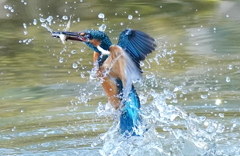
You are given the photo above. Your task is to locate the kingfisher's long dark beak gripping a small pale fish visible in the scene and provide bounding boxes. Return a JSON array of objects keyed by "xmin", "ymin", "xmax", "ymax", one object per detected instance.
[{"xmin": 52, "ymin": 31, "xmax": 87, "ymax": 42}]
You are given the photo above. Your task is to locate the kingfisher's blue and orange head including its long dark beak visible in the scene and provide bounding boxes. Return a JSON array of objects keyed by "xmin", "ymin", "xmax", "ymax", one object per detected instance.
[{"xmin": 52, "ymin": 30, "xmax": 112, "ymax": 54}]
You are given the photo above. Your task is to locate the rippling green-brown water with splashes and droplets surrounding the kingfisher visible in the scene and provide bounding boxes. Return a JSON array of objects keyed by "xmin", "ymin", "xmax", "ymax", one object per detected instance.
[{"xmin": 0, "ymin": 0, "xmax": 240, "ymax": 156}]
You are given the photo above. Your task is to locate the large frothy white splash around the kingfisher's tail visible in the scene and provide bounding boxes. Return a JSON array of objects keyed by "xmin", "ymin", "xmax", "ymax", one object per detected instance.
[{"xmin": 93, "ymin": 86, "xmax": 225, "ymax": 156}]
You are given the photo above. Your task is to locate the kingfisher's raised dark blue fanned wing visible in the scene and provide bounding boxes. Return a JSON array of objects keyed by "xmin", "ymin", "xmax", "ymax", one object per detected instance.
[{"xmin": 118, "ymin": 29, "xmax": 156, "ymax": 71}]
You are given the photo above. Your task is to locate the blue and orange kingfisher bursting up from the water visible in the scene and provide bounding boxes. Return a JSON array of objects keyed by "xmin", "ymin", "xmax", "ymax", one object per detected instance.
[{"xmin": 52, "ymin": 28, "xmax": 156, "ymax": 136}]
